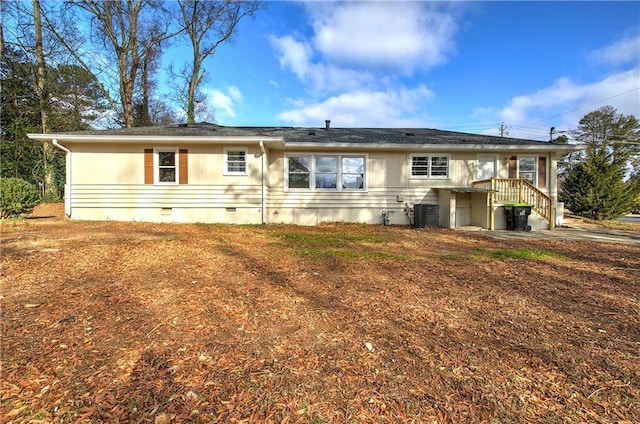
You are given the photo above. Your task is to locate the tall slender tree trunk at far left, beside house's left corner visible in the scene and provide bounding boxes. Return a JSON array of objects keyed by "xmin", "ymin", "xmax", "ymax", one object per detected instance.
[{"xmin": 33, "ymin": 0, "xmax": 58, "ymax": 198}]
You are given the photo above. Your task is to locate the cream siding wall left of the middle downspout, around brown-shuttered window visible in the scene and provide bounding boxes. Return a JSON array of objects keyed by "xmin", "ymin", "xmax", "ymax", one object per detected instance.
[{"xmin": 68, "ymin": 143, "xmax": 262, "ymax": 224}]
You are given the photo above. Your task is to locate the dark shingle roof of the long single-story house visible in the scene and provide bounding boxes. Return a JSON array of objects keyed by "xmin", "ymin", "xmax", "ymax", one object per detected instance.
[{"xmin": 65, "ymin": 123, "xmax": 549, "ymax": 146}]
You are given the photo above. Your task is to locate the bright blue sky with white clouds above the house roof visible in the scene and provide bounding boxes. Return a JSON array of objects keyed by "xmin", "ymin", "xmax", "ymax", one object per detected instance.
[{"xmin": 161, "ymin": 1, "xmax": 640, "ymax": 140}]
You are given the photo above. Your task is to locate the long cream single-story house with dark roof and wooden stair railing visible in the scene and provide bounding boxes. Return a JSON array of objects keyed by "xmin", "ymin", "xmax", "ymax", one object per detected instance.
[{"xmin": 29, "ymin": 121, "xmax": 580, "ymax": 229}]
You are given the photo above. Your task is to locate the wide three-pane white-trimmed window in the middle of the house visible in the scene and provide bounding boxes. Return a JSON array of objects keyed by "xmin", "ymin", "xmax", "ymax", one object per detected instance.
[{"xmin": 285, "ymin": 154, "xmax": 366, "ymax": 191}]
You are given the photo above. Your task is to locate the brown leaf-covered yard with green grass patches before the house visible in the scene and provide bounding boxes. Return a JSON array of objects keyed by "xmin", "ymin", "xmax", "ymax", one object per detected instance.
[{"xmin": 0, "ymin": 205, "xmax": 640, "ymax": 424}]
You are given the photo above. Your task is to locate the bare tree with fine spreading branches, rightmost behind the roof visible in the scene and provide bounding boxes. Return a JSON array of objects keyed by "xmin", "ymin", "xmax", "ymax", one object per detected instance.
[{"xmin": 174, "ymin": 0, "xmax": 263, "ymax": 124}]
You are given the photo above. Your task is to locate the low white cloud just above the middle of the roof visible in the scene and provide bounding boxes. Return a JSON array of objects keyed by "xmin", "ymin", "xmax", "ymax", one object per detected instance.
[{"xmin": 278, "ymin": 86, "xmax": 433, "ymax": 127}]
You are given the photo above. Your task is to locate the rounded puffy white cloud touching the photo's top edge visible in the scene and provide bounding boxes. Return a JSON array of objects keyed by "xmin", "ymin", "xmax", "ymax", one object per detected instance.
[{"xmin": 308, "ymin": 2, "xmax": 457, "ymax": 73}]
